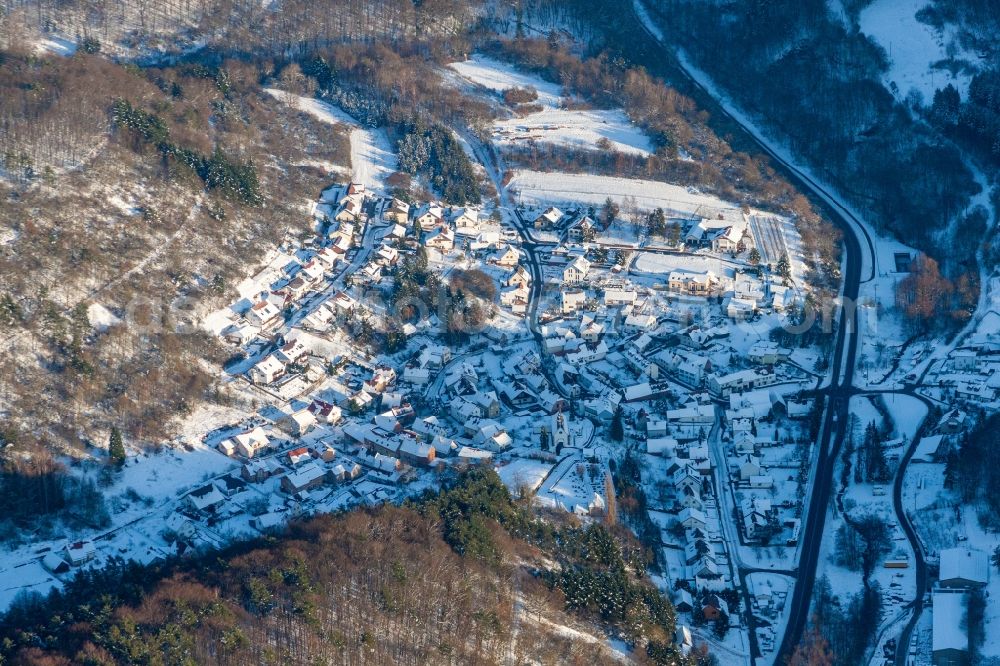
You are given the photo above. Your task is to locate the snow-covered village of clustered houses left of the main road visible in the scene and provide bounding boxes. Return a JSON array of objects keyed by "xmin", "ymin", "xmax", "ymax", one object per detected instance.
[{"xmin": 1, "ymin": 148, "xmax": 822, "ymax": 652}]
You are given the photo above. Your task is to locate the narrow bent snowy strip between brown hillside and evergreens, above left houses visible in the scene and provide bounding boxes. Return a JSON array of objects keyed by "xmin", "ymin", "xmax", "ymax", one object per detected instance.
[{"xmin": 265, "ymin": 88, "xmax": 399, "ymax": 192}]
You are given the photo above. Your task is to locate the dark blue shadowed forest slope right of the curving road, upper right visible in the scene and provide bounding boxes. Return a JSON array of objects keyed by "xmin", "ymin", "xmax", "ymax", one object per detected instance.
[{"xmin": 636, "ymin": 0, "xmax": 996, "ymax": 276}]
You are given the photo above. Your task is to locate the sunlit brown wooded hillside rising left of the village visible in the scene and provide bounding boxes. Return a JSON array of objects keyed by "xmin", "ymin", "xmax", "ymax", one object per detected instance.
[{"xmin": 0, "ymin": 51, "xmax": 349, "ymax": 540}]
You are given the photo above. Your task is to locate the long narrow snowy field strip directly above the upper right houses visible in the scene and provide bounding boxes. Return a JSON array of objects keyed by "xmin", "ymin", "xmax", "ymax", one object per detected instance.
[{"xmin": 510, "ymin": 170, "xmax": 737, "ymax": 217}]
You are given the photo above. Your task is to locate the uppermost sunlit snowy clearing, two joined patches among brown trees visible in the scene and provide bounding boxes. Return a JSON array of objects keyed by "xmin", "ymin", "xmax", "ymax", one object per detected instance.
[{"xmin": 449, "ymin": 55, "xmax": 653, "ymax": 155}]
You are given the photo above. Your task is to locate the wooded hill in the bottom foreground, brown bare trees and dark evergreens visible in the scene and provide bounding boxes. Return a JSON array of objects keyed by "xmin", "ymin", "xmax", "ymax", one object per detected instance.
[{"xmin": 0, "ymin": 470, "xmax": 710, "ymax": 666}]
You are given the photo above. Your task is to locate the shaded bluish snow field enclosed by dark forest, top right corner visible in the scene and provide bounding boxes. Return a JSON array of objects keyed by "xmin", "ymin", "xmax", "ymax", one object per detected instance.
[{"xmin": 859, "ymin": 0, "xmax": 978, "ymax": 104}]
